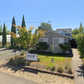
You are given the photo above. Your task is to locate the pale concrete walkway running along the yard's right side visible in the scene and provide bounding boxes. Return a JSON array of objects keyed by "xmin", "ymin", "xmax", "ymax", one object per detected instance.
[{"xmin": 72, "ymin": 48, "xmax": 84, "ymax": 84}]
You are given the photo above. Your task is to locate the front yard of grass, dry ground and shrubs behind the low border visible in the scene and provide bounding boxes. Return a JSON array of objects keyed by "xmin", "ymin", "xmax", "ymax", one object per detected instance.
[{"xmin": 9, "ymin": 52, "xmax": 72, "ymax": 74}]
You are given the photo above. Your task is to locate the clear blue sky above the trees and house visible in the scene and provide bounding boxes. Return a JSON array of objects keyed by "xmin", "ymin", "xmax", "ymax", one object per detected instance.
[{"xmin": 0, "ymin": 0, "xmax": 84, "ymax": 30}]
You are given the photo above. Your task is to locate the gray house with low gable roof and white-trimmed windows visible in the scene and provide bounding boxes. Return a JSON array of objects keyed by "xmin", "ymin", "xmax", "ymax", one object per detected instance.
[{"xmin": 38, "ymin": 30, "xmax": 72, "ymax": 53}]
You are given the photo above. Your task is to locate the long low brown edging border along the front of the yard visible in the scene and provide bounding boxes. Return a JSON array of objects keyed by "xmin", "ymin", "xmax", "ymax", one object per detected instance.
[{"xmin": 23, "ymin": 66, "xmax": 74, "ymax": 79}]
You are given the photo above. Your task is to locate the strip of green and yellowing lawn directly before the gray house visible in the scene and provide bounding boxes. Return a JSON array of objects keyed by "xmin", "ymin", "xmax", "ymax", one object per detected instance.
[{"xmin": 38, "ymin": 54, "xmax": 71, "ymax": 64}]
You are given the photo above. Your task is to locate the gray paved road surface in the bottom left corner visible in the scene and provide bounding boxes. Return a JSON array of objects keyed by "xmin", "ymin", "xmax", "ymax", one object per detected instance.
[{"xmin": 0, "ymin": 72, "xmax": 37, "ymax": 84}]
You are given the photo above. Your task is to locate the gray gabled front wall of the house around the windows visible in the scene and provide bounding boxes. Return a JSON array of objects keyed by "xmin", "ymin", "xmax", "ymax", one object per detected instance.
[{"xmin": 38, "ymin": 33, "xmax": 68, "ymax": 53}]
